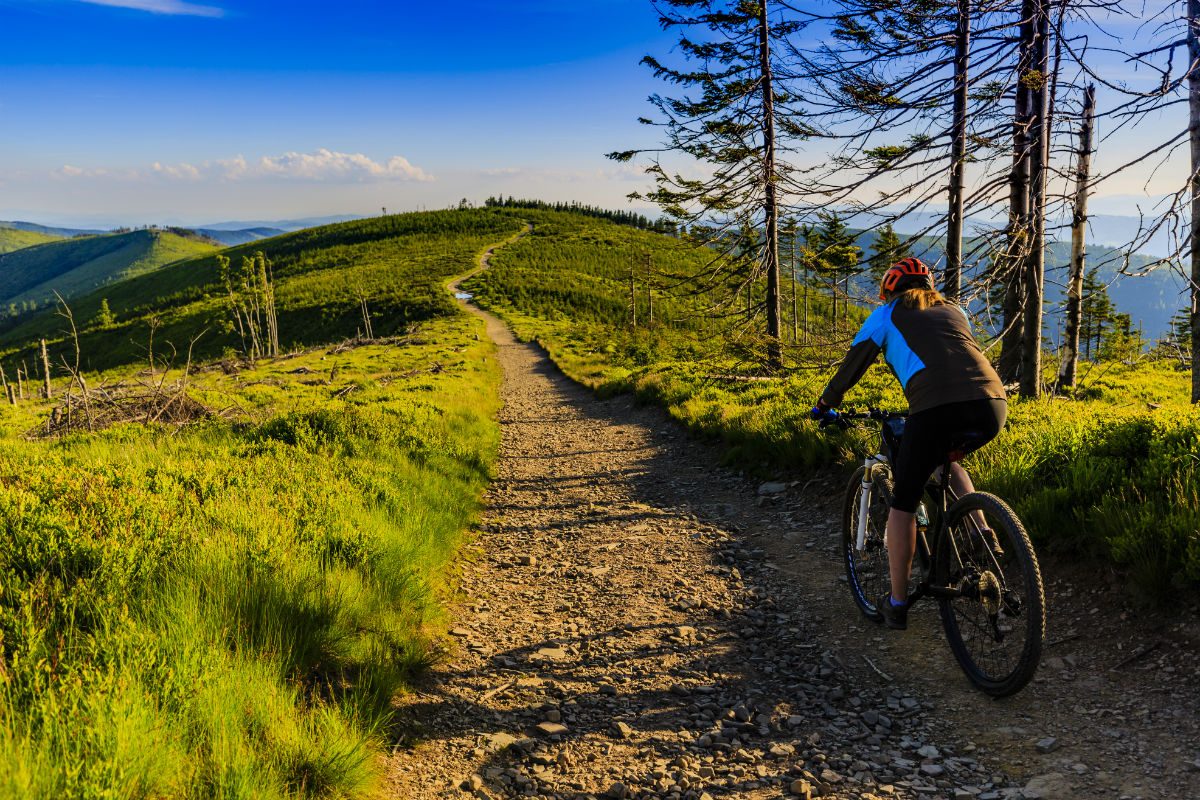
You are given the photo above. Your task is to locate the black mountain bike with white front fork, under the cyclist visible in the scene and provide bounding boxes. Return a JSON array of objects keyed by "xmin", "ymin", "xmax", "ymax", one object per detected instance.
[{"xmin": 822, "ymin": 409, "xmax": 1045, "ymax": 697}]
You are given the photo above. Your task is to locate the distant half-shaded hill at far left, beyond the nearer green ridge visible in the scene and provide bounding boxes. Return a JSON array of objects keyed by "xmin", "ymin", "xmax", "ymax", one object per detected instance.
[{"xmin": 0, "ymin": 230, "xmax": 217, "ymax": 312}]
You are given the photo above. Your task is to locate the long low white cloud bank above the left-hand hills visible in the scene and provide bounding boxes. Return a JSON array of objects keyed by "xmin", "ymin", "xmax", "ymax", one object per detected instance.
[{"xmin": 52, "ymin": 148, "xmax": 433, "ymax": 184}]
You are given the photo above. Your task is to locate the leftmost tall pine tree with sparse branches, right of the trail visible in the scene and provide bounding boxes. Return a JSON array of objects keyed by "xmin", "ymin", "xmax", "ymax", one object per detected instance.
[{"xmin": 608, "ymin": 0, "xmax": 811, "ymax": 368}]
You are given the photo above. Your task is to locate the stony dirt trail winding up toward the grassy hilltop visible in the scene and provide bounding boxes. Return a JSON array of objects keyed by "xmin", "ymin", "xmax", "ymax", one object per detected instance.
[{"xmin": 390, "ymin": 235, "xmax": 1200, "ymax": 800}]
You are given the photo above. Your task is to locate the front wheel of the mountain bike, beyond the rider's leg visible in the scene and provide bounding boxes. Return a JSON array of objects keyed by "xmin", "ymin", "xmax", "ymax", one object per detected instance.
[{"xmin": 841, "ymin": 464, "xmax": 892, "ymax": 622}]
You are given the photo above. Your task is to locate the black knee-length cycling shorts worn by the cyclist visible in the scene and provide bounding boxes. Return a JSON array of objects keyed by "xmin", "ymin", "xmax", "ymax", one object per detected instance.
[{"xmin": 892, "ymin": 399, "xmax": 1008, "ymax": 513}]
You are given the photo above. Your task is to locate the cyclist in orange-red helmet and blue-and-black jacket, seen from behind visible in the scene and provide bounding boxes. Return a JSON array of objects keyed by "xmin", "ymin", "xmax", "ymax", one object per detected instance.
[{"xmin": 812, "ymin": 258, "xmax": 1008, "ymax": 630}]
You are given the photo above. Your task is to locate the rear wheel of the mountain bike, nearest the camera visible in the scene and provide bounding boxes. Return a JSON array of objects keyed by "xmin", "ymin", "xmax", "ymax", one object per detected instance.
[{"xmin": 937, "ymin": 492, "xmax": 1045, "ymax": 697}]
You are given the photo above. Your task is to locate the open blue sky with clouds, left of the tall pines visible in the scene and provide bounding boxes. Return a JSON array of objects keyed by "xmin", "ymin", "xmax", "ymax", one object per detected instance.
[{"xmin": 0, "ymin": 0, "xmax": 1186, "ymax": 225}]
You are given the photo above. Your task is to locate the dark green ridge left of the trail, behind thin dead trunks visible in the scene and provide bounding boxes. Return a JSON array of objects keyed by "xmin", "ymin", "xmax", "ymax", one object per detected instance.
[{"xmin": 0, "ymin": 211, "xmax": 522, "ymax": 372}]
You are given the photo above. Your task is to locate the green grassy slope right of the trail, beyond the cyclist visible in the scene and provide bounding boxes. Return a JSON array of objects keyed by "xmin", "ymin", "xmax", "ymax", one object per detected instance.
[{"xmin": 472, "ymin": 209, "xmax": 1200, "ymax": 593}]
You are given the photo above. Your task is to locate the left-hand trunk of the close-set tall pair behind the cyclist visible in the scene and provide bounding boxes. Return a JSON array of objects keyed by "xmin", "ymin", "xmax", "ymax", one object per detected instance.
[{"xmin": 998, "ymin": 0, "xmax": 1037, "ymax": 384}]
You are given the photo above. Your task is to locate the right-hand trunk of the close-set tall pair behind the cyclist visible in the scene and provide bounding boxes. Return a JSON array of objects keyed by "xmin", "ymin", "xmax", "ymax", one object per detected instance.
[{"xmin": 1021, "ymin": 0, "xmax": 1050, "ymax": 397}]
